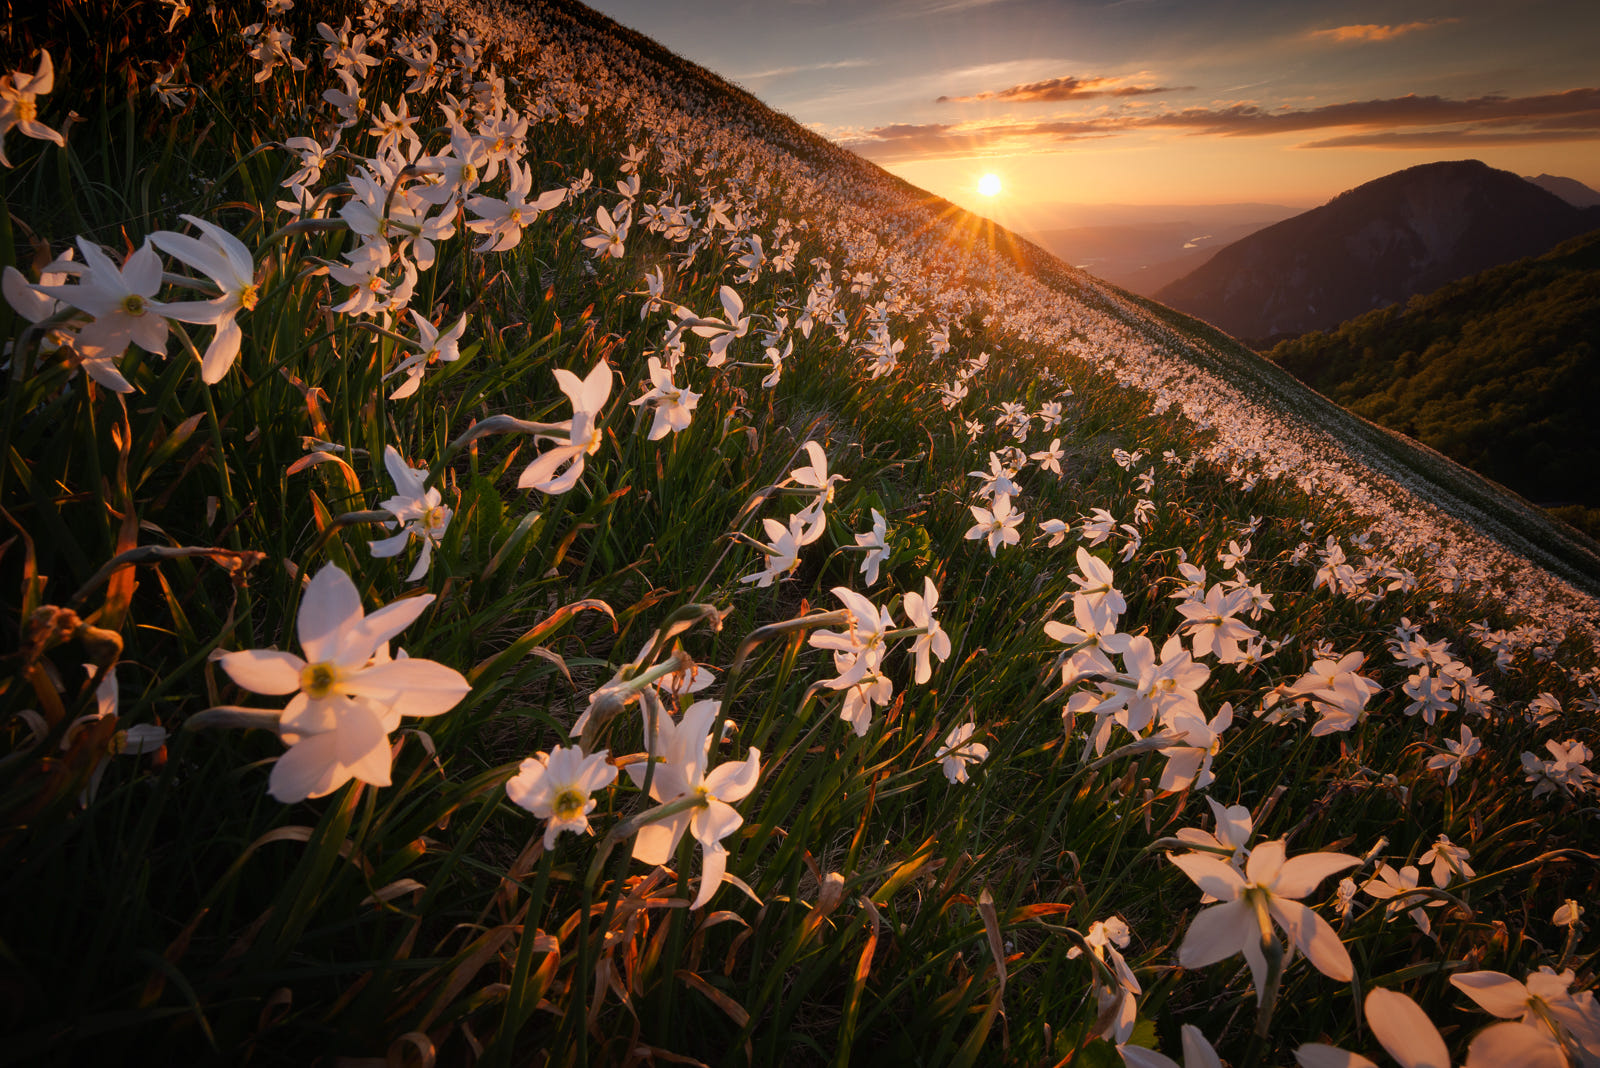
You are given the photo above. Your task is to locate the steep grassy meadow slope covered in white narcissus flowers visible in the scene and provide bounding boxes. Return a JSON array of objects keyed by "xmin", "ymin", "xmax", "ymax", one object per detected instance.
[{"xmin": 0, "ymin": 0, "xmax": 1600, "ymax": 1068}]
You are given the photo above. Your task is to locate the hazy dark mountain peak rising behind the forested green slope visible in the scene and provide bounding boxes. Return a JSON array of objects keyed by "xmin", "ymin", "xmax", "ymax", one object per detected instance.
[{"xmin": 1155, "ymin": 160, "xmax": 1600, "ymax": 341}]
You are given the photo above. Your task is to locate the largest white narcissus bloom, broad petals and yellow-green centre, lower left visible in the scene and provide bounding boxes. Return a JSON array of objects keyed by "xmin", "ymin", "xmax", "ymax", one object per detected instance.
[{"xmin": 218, "ymin": 564, "xmax": 472, "ymax": 801}]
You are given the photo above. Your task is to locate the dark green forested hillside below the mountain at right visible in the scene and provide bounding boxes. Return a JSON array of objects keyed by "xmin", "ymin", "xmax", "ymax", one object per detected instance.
[{"xmin": 1270, "ymin": 232, "xmax": 1600, "ymax": 507}]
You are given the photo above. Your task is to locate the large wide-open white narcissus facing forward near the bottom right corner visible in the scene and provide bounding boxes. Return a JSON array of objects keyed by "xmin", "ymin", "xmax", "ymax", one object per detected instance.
[{"xmin": 1168, "ymin": 839, "xmax": 1362, "ymax": 1001}]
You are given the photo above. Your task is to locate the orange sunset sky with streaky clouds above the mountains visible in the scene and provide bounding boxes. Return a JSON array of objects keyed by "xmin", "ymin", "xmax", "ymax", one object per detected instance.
[{"xmin": 590, "ymin": 0, "xmax": 1600, "ymax": 230}]
